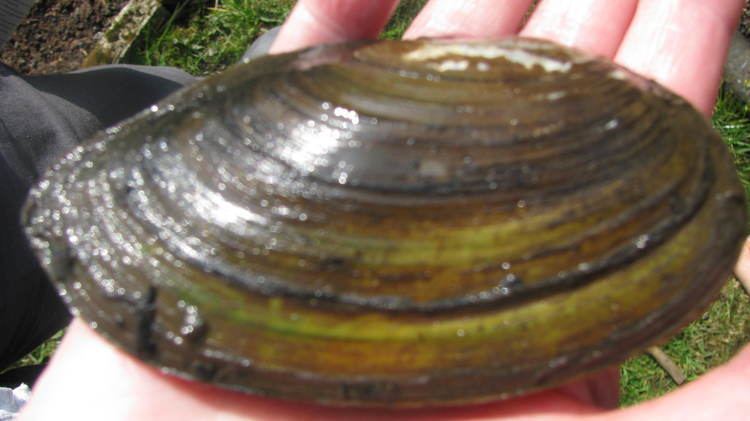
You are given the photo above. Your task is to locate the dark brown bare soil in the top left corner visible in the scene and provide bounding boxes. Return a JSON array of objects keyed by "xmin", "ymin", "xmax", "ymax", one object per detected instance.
[{"xmin": 0, "ymin": 0, "xmax": 127, "ymax": 74}]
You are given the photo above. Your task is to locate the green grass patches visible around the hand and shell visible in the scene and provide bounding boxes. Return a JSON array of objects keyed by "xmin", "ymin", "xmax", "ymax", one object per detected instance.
[{"xmin": 11, "ymin": 0, "xmax": 750, "ymax": 405}]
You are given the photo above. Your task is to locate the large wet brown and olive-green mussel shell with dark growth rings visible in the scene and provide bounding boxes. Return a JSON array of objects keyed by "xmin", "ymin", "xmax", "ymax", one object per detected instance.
[{"xmin": 25, "ymin": 39, "xmax": 745, "ymax": 406}]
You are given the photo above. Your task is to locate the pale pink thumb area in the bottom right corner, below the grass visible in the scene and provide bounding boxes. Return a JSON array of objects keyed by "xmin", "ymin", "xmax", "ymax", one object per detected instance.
[{"xmin": 616, "ymin": 347, "xmax": 750, "ymax": 421}]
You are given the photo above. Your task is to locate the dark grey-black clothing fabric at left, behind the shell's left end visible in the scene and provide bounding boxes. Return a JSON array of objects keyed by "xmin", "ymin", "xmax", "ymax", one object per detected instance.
[{"xmin": 0, "ymin": 64, "xmax": 194, "ymax": 370}]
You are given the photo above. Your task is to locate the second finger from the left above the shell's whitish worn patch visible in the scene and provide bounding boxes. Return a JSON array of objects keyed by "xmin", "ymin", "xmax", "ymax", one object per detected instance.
[{"xmin": 404, "ymin": 0, "xmax": 531, "ymax": 39}]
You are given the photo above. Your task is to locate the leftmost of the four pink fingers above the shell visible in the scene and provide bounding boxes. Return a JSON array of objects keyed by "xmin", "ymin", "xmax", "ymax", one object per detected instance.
[{"xmin": 270, "ymin": 0, "xmax": 398, "ymax": 53}]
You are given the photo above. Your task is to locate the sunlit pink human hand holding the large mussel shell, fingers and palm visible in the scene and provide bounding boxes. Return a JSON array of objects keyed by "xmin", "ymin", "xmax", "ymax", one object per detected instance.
[{"xmin": 21, "ymin": 0, "xmax": 750, "ymax": 420}]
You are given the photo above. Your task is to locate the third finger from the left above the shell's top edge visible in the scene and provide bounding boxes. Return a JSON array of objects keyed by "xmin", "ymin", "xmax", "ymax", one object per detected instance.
[{"xmin": 521, "ymin": 0, "xmax": 638, "ymax": 58}]
